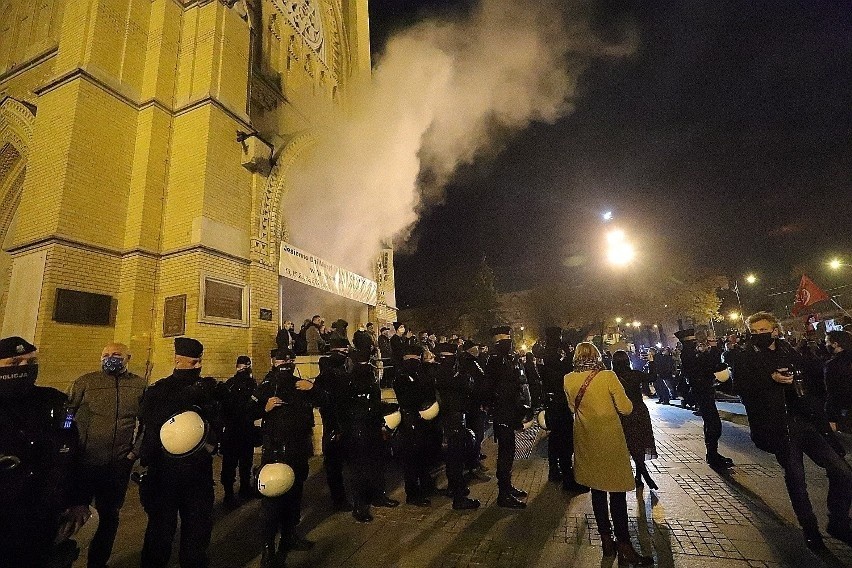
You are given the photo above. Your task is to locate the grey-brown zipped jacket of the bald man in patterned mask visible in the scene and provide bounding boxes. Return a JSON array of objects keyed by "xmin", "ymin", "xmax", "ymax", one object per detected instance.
[{"xmin": 68, "ymin": 371, "xmax": 148, "ymax": 466}]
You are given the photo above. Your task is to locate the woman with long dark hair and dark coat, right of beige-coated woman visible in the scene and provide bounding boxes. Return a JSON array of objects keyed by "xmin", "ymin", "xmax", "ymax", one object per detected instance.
[{"xmin": 612, "ymin": 350, "xmax": 657, "ymax": 489}]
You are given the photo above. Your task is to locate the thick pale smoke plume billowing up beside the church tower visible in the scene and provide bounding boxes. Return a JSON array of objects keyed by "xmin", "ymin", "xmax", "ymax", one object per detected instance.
[{"xmin": 284, "ymin": 0, "xmax": 632, "ymax": 276}]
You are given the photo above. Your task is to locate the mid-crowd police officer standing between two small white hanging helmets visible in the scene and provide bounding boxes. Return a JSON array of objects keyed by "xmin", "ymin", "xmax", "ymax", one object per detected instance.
[{"xmin": 393, "ymin": 343, "xmax": 436, "ymax": 507}]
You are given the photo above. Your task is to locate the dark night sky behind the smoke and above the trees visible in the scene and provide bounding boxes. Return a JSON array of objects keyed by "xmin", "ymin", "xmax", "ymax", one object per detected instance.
[{"xmin": 370, "ymin": 0, "xmax": 852, "ymax": 307}]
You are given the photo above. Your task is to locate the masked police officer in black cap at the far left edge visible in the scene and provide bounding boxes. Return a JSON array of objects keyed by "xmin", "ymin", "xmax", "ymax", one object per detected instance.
[{"xmin": 0, "ymin": 337, "xmax": 93, "ymax": 568}]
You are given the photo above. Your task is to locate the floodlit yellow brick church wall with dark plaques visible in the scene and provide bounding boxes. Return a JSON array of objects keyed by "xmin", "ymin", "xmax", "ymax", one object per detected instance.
[{"xmin": 0, "ymin": 0, "xmax": 393, "ymax": 389}]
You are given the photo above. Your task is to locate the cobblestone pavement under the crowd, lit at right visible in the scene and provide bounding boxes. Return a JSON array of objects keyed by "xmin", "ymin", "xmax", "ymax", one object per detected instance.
[{"xmin": 88, "ymin": 401, "xmax": 852, "ymax": 568}]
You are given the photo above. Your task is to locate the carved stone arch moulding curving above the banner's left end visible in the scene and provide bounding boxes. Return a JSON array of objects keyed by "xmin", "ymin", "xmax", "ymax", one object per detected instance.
[{"xmin": 252, "ymin": 131, "xmax": 317, "ymax": 270}]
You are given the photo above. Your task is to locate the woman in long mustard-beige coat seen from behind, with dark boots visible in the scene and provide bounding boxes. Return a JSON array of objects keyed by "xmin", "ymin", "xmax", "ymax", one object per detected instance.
[{"xmin": 564, "ymin": 343, "xmax": 654, "ymax": 566}]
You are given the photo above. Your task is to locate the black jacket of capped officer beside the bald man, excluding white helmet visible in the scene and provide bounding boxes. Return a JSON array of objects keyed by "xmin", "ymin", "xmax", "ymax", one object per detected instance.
[{"xmin": 139, "ymin": 369, "xmax": 222, "ymax": 470}]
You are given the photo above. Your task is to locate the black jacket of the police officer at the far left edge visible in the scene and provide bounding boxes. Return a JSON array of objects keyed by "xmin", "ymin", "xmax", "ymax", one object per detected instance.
[{"xmin": 0, "ymin": 387, "xmax": 89, "ymax": 566}]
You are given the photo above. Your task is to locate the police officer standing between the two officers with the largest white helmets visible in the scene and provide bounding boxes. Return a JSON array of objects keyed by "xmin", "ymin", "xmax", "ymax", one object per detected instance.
[{"xmin": 221, "ymin": 355, "xmax": 257, "ymax": 503}]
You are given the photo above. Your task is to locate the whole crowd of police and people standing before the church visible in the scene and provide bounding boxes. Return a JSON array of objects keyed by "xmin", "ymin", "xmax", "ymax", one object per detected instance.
[{"xmin": 5, "ymin": 312, "xmax": 852, "ymax": 568}]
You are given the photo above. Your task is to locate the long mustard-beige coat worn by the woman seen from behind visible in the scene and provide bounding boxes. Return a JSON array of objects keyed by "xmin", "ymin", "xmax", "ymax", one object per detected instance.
[{"xmin": 564, "ymin": 370, "xmax": 636, "ymax": 492}]
